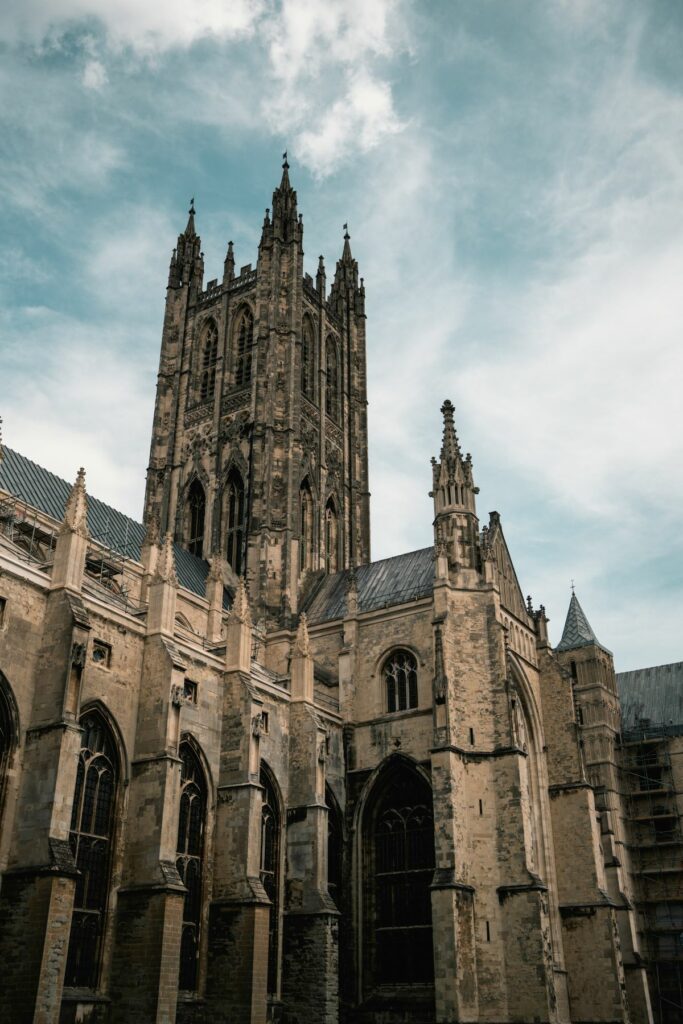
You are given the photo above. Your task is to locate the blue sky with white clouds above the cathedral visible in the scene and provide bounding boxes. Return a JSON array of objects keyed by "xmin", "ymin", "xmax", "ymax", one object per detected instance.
[{"xmin": 0, "ymin": 0, "xmax": 683, "ymax": 670}]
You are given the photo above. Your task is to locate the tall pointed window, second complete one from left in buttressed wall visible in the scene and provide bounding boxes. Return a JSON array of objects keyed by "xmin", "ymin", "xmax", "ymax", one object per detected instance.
[{"xmin": 175, "ymin": 741, "xmax": 207, "ymax": 992}]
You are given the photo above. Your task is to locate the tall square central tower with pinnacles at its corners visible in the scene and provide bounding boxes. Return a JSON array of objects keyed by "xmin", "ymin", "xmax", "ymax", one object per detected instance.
[{"xmin": 144, "ymin": 155, "xmax": 370, "ymax": 625}]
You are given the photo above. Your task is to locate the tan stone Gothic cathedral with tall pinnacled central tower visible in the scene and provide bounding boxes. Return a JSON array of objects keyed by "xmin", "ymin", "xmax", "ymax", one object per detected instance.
[{"xmin": 0, "ymin": 160, "xmax": 663, "ymax": 1024}]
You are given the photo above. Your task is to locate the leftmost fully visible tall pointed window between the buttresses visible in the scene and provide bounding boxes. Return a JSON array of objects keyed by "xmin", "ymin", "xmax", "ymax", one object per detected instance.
[{"xmin": 65, "ymin": 711, "xmax": 119, "ymax": 988}]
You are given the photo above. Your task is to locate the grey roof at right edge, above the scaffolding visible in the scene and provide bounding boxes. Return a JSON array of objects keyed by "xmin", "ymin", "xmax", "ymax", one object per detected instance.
[{"xmin": 616, "ymin": 662, "xmax": 683, "ymax": 733}]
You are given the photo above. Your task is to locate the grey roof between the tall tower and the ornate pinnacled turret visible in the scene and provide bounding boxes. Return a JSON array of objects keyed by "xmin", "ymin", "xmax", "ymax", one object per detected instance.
[{"xmin": 304, "ymin": 548, "xmax": 434, "ymax": 624}]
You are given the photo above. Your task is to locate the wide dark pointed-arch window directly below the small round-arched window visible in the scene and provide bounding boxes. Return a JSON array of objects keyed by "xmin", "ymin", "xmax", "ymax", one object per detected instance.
[{"xmin": 365, "ymin": 765, "xmax": 434, "ymax": 987}]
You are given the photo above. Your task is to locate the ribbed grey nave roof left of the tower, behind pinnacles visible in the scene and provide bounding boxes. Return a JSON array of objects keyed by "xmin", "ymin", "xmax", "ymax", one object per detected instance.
[{"xmin": 0, "ymin": 446, "xmax": 209, "ymax": 597}]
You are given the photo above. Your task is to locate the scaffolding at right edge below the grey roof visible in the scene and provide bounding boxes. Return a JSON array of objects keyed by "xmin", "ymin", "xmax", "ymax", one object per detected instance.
[{"xmin": 622, "ymin": 722, "xmax": 683, "ymax": 1024}]
